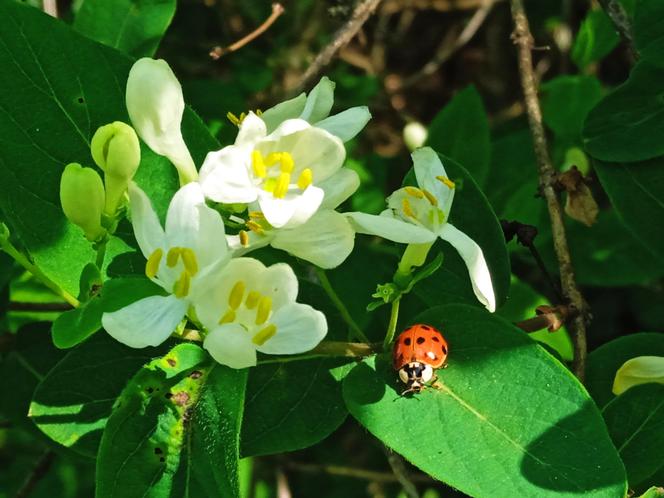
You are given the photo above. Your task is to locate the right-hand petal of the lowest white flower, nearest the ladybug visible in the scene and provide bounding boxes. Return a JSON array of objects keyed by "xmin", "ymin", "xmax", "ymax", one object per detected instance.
[{"xmin": 256, "ymin": 303, "xmax": 327, "ymax": 354}]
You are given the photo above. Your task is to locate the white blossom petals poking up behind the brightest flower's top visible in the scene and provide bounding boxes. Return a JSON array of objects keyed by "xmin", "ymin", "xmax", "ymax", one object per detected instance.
[{"xmin": 261, "ymin": 76, "xmax": 371, "ymax": 142}]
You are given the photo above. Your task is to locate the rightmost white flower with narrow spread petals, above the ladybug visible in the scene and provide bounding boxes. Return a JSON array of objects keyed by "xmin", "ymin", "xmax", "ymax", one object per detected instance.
[{"xmin": 347, "ymin": 147, "xmax": 496, "ymax": 312}]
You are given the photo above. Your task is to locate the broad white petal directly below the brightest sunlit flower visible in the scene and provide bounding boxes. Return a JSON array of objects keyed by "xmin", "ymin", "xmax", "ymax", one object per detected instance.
[{"xmin": 272, "ymin": 210, "xmax": 355, "ymax": 269}]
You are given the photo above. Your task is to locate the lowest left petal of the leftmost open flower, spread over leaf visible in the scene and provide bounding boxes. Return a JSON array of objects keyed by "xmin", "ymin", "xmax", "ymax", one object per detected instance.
[{"xmin": 101, "ymin": 295, "xmax": 188, "ymax": 348}]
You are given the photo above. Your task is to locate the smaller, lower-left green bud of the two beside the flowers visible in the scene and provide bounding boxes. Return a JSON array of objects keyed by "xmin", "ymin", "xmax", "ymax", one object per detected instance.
[{"xmin": 60, "ymin": 163, "xmax": 106, "ymax": 242}]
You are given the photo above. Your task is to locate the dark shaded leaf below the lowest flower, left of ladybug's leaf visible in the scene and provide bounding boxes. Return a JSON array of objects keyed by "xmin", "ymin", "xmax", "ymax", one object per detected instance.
[{"xmin": 241, "ymin": 358, "xmax": 348, "ymax": 457}]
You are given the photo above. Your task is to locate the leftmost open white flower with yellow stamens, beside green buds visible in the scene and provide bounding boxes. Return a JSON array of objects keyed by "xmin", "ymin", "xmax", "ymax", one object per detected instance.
[{"xmin": 102, "ymin": 182, "xmax": 230, "ymax": 348}]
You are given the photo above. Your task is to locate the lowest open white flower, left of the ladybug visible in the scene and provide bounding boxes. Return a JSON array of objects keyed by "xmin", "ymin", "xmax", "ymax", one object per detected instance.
[{"xmin": 196, "ymin": 258, "xmax": 327, "ymax": 368}]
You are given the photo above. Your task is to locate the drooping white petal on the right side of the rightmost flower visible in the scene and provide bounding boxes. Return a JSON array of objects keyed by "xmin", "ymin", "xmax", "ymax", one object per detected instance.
[{"xmin": 439, "ymin": 223, "xmax": 496, "ymax": 313}]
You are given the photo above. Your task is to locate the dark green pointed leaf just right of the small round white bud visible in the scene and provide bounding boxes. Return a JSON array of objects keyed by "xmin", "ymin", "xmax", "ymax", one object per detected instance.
[{"xmin": 427, "ymin": 85, "xmax": 491, "ymax": 186}]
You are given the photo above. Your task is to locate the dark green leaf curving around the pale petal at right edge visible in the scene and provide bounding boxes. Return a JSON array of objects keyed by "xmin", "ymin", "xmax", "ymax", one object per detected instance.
[{"xmin": 586, "ymin": 332, "xmax": 664, "ymax": 407}]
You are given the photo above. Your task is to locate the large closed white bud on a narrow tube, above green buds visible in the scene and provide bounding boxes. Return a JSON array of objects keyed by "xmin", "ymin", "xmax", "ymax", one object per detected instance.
[{"xmin": 126, "ymin": 57, "xmax": 198, "ymax": 185}]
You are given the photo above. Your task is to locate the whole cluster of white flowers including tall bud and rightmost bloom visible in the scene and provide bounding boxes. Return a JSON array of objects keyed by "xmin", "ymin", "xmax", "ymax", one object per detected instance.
[{"xmin": 102, "ymin": 58, "xmax": 495, "ymax": 368}]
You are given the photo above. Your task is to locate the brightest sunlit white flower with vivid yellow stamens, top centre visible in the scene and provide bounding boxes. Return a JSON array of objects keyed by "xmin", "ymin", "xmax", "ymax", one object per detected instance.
[{"xmin": 199, "ymin": 112, "xmax": 346, "ymax": 228}]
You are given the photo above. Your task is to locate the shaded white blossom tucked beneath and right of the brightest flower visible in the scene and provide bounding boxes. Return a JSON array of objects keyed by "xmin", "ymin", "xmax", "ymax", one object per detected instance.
[{"xmin": 227, "ymin": 169, "xmax": 360, "ymax": 269}]
